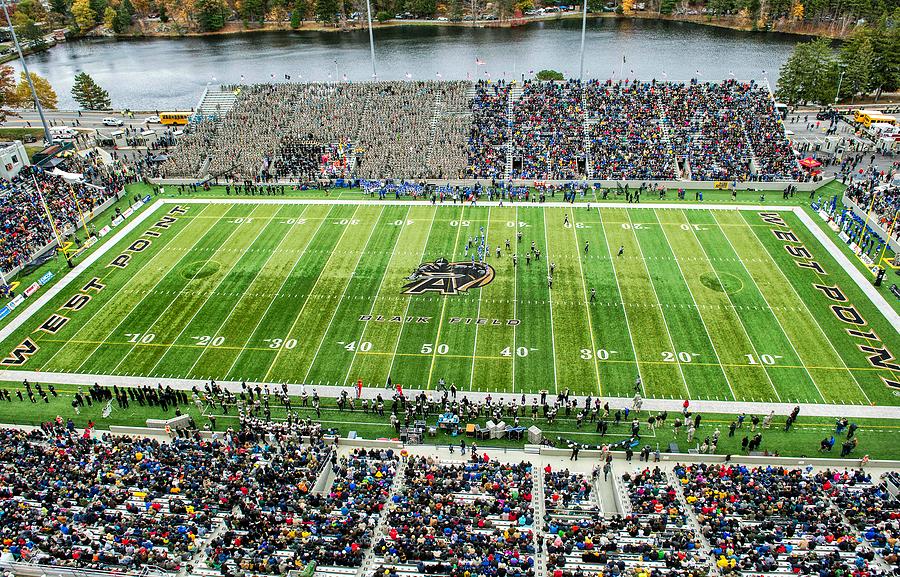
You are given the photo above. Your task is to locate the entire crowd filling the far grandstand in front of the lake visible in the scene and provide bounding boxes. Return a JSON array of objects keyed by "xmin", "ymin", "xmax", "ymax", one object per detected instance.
[{"xmin": 160, "ymin": 80, "xmax": 803, "ymax": 181}]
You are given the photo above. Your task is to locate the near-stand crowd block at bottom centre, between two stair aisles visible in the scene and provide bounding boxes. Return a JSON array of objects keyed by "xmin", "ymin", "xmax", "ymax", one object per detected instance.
[{"xmin": 374, "ymin": 448, "xmax": 535, "ymax": 577}]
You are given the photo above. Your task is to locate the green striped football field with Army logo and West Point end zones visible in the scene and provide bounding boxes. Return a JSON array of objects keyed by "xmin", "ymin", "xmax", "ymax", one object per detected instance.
[{"xmin": 2, "ymin": 200, "xmax": 900, "ymax": 404}]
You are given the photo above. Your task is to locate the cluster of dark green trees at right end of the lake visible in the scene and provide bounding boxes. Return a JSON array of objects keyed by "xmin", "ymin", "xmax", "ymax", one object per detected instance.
[{"xmin": 776, "ymin": 8, "xmax": 900, "ymax": 104}]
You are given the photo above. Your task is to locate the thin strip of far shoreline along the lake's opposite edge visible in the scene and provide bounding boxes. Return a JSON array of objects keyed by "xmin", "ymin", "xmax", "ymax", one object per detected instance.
[{"xmin": 102, "ymin": 12, "xmax": 855, "ymax": 40}]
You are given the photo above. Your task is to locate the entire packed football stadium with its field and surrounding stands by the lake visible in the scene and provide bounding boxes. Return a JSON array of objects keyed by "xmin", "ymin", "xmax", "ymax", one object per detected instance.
[{"xmin": 0, "ymin": 19, "xmax": 900, "ymax": 577}]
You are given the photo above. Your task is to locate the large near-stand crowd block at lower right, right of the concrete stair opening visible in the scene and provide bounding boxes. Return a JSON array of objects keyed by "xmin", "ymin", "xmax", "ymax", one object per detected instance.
[{"xmin": 675, "ymin": 463, "xmax": 881, "ymax": 577}]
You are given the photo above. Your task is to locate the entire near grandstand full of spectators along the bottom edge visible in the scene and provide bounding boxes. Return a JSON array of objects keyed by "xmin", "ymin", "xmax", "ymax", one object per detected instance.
[{"xmin": 0, "ymin": 418, "xmax": 900, "ymax": 577}]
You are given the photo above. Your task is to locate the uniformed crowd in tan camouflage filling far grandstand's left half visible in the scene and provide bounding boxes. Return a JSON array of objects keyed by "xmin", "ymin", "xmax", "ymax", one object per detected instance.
[{"xmin": 160, "ymin": 81, "xmax": 469, "ymax": 181}]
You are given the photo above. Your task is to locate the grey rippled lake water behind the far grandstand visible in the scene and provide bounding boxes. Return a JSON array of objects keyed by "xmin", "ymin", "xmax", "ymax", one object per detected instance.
[{"xmin": 13, "ymin": 18, "xmax": 799, "ymax": 110}]
